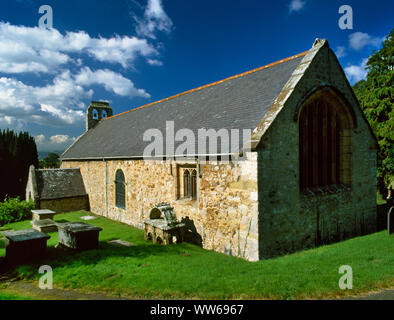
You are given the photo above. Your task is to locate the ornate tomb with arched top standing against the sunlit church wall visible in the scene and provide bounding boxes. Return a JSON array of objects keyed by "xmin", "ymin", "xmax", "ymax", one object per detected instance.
[{"xmin": 144, "ymin": 202, "xmax": 185, "ymax": 244}]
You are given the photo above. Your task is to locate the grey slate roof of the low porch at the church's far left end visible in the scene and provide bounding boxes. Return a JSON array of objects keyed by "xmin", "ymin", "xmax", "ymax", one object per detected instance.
[{"xmin": 36, "ymin": 168, "xmax": 87, "ymax": 200}]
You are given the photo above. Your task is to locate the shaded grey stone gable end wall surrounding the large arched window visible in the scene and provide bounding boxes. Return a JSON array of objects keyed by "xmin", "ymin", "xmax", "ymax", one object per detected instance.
[{"xmin": 254, "ymin": 41, "xmax": 376, "ymax": 258}]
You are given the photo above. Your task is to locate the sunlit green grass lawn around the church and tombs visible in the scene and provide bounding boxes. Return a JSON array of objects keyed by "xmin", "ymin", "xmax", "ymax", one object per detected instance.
[{"xmin": 0, "ymin": 212, "xmax": 394, "ymax": 299}]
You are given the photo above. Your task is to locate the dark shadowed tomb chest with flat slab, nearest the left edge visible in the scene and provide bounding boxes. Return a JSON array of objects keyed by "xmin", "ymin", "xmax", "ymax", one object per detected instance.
[{"xmin": 2, "ymin": 229, "xmax": 50, "ymax": 263}]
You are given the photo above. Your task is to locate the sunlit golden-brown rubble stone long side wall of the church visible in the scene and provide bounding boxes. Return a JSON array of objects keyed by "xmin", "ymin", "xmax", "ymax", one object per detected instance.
[{"xmin": 62, "ymin": 153, "xmax": 258, "ymax": 260}]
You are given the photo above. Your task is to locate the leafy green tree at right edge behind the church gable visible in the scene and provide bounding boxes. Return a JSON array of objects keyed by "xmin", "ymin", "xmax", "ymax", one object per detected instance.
[{"xmin": 353, "ymin": 29, "xmax": 394, "ymax": 197}]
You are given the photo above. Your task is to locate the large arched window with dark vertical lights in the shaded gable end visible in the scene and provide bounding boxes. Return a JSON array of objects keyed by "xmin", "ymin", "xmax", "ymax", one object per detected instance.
[{"xmin": 299, "ymin": 90, "xmax": 352, "ymax": 192}]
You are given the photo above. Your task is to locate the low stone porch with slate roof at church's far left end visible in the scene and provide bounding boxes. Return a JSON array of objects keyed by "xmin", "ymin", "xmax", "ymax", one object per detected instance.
[{"xmin": 26, "ymin": 165, "xmax": 89, "ymax": 213}]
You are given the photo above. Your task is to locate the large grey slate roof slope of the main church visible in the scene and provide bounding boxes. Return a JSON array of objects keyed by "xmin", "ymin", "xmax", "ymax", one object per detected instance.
[{"xmin": 61, "ymin": 52, "xmax": 306, "ymax": 160}]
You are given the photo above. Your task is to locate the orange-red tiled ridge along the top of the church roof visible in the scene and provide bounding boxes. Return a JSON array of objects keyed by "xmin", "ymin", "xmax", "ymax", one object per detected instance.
[{"xmin": 103, "ymin": 50, "xmax": 309, "ymax": 120}]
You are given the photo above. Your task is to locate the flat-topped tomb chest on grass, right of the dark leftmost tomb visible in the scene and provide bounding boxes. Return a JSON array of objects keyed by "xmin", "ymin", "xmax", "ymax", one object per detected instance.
[{"xmin": 58, "ymin": 222, "xmax": 103, "ymax": 251}]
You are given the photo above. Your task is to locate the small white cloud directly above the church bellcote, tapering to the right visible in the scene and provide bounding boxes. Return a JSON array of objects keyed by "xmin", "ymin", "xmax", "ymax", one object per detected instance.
[{"xmin": 75, "ymin": 67, "xmax": 150, "ymax": 98}]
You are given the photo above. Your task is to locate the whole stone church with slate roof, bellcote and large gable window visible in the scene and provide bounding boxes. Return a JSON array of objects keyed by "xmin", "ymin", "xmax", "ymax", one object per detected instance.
[{"xmin": 61, "ymin": 39, "xmax": 378, "ymax": 261}]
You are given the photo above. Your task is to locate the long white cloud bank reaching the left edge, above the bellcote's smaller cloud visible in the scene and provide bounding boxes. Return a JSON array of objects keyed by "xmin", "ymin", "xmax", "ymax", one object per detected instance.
[{"xmin": 0, "ymin": 22, "xmax": 158, "ymax": 74}]
